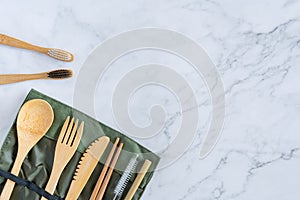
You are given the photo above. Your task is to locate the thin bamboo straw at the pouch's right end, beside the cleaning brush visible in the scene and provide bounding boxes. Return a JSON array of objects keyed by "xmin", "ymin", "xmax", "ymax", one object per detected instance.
[{"xmin": 124, "ymin": 160, "xmax": 152, "ymax": 200}]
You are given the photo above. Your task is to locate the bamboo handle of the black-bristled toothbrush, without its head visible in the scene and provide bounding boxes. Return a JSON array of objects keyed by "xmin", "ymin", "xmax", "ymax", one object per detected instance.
[{"xmin": 0, "ymin": 73, "xmax": 47, "ymax": 85}]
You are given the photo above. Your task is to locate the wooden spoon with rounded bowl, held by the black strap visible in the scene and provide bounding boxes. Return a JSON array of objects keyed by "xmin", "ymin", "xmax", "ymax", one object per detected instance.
[{"xmin": 0, "ymin": 99, "xmax": 54, "ymax": 200}]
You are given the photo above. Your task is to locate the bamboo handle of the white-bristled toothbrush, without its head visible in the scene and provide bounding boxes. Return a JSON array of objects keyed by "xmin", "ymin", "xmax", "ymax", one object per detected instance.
[{"xmin": 0, "ymin": 34, "xmax": 48, "ymax": 53}]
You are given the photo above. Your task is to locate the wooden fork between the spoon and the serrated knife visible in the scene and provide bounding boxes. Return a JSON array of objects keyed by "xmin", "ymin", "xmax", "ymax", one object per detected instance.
[{"xmin": 41, "ymin": 117, "xmax": 84, "ymax": 200}]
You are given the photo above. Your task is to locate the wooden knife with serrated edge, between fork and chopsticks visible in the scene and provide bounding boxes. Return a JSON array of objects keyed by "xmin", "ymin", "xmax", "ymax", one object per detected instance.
[{"xmin": 65, "ymin": 136, "xmax": 109, "ymax": 200}]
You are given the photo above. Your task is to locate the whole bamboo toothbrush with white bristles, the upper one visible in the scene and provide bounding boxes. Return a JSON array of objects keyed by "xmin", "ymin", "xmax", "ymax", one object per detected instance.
[{"xmin": 0, "ymin": 34, "xmax": 74, "ymax": 62}]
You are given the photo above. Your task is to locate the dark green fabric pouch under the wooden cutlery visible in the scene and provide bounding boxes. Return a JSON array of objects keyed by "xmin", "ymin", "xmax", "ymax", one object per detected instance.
[{"xmin": 0, "ymin": 90, "xmax": 159, "ymax": 200}]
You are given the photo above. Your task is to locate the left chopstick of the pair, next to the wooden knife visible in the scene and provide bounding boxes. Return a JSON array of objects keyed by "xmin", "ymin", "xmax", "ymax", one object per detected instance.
[{"xmin": 90, "ymin": 138, "xmax": 120, "ymax": 200}]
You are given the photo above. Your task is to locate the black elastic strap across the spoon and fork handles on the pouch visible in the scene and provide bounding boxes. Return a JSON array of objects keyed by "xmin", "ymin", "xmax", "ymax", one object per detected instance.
[{"xmin": 0, "ymin": 169, "xmax": 63, "ymax": 200}]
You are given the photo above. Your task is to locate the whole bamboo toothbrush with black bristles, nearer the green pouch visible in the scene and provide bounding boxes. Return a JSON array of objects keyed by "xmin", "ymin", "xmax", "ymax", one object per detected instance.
[{"xmin": 0, "ymin": 69, "xmax": 73, "ymax": 85}]
